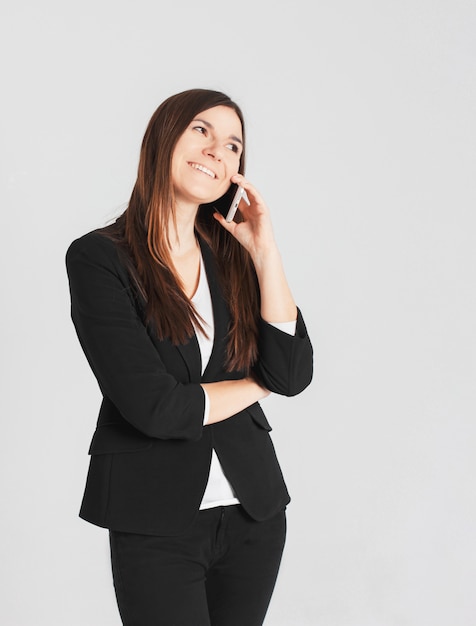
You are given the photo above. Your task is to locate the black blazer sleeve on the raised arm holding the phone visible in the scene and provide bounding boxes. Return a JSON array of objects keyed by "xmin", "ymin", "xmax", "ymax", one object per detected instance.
[{"xmin": 253, "ymin": 309, "xmax": 313, "ymax": 396}]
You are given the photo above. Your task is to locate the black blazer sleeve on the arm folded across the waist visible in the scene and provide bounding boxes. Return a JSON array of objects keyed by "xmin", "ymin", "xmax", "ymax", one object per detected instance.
[{"xmin": 66, "ymin": 233, "xmax": 205, "ymax": 440}]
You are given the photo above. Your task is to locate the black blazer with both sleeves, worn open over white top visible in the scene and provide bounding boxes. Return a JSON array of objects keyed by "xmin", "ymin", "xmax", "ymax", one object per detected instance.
[{"xmin": 66, "ymin": 231, "xmax": 312, "ymax": 535}]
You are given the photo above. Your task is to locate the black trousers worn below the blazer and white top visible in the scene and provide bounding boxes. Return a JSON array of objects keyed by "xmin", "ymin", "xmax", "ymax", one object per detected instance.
[{"xmin": 110, "ymin": 505, "xmax": 286, "ymax": 626}]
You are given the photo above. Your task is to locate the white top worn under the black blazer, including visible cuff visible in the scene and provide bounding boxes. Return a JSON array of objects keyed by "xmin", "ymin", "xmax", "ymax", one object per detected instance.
[{"xmin": 192, "ymin": 252, "xmax": 296, "ymax": 510}]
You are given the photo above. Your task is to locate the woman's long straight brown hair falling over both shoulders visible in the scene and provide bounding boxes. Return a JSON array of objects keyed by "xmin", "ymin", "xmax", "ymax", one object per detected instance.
[{"xmin": 106, "ymin": 89, "xmax": 259, "ymax": 372}]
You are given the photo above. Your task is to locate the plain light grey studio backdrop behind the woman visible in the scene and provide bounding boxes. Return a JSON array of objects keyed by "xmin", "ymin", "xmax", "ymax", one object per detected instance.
[{"xmin": 0, "ymin": 0, "xmax": 476, "ymax": 626}]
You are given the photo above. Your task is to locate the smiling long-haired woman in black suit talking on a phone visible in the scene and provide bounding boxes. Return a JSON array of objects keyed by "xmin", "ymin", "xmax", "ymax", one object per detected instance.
[{"xmin": 67, "ymin": 89, "xmax": 312, "ymax": 626}]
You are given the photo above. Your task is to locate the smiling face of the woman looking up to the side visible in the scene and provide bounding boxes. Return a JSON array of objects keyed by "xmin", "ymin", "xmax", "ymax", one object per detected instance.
[{"xmin": 172, "ymin": 106, "xmax": 243, "ymax": 206}]
